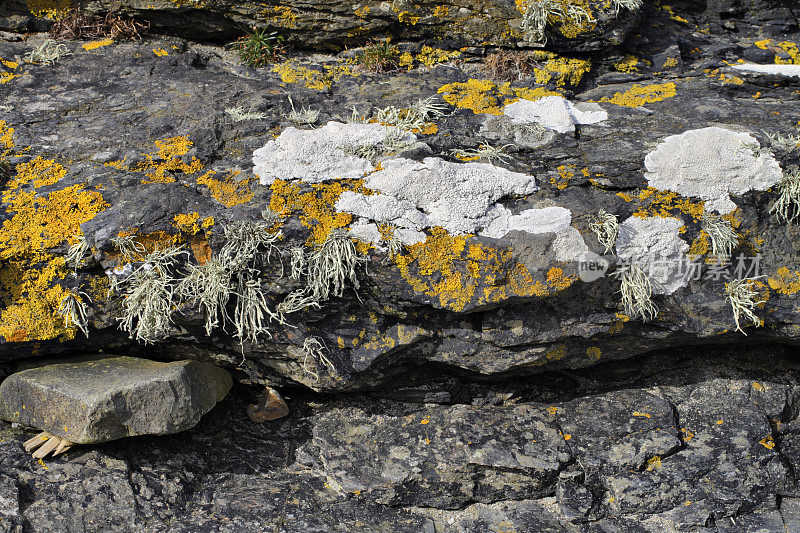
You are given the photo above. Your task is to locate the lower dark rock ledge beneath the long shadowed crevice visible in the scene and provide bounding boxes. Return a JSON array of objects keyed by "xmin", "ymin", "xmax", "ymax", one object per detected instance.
[{"xmin": 0, "ymin": 348, "xmax": 800, "ymax": 533}]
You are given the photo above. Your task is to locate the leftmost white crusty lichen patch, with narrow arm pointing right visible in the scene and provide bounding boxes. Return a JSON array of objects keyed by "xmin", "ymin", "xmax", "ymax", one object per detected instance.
[{"xmin": 253, "ymin": 122, "xmax": 416, "ymax": 185}]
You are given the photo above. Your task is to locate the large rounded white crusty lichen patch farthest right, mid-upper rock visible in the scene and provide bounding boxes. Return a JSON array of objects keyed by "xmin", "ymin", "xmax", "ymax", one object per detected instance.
[{"xmin": 644, "ymin": 127, "xmax": 782, "ymax": 215}]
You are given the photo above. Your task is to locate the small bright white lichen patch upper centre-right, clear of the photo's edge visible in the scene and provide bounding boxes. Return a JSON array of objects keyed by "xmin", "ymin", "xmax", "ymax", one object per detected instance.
[{"xmin": 503, "ymin": 96, "xmax": 608, "ymax": 133}]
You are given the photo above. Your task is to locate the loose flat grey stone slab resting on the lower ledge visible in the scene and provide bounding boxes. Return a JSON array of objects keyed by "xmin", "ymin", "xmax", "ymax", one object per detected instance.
[{"xmin": 0, "ymin": 357, "xmax": 233, "ymax": 444}]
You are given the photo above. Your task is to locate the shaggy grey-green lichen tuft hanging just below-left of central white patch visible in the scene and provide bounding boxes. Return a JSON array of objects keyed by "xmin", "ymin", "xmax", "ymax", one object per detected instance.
[{"xmin": 308, "ymin": 229, "xmax": 366, "ymax": 302}]
